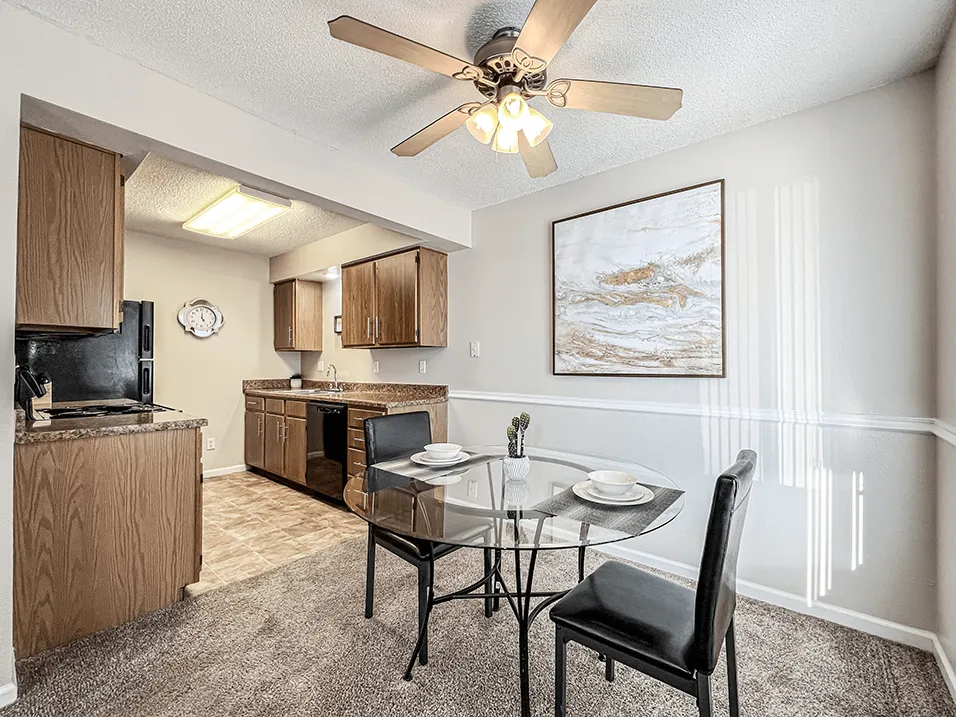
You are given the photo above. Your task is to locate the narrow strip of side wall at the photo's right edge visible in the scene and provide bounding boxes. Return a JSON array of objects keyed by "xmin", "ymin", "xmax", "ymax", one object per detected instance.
[{"xmin": 936, "ymin": 16, "xmax": 956, "ymax": 676}]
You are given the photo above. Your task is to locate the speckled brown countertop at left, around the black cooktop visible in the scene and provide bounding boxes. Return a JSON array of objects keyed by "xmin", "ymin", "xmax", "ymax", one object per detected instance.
[{"xmin": 13, "ymin": 401, "xmax": 208, "ymax": 443}]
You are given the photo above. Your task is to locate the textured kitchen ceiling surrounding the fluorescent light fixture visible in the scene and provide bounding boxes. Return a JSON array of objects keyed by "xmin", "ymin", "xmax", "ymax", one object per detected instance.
[{"xmin": 126, "ymin": 152, "xmax": 363, "ymax": 256}]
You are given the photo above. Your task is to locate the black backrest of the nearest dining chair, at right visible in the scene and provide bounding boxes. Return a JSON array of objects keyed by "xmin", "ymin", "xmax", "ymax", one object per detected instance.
[{"xmin": 694, "ymin": 450, "xmax": 757, "ymax": 675}]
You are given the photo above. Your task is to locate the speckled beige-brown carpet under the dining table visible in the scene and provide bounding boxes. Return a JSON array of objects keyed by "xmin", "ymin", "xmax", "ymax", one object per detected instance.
[{"xmin": 0, "ymin": 540, "xmax": 956, "ymax": 717}]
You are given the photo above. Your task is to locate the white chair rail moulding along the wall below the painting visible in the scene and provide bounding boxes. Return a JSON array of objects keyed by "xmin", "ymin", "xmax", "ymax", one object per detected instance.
[{"xmin": 448, "ymin": 391, "xmax": 932, "ymax": 438}]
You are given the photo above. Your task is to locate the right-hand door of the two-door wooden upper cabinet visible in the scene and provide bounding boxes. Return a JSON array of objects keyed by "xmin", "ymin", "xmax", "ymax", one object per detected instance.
[{"xmin": 375, "ymin": 251, "xmax": 418, "ymax": 346}]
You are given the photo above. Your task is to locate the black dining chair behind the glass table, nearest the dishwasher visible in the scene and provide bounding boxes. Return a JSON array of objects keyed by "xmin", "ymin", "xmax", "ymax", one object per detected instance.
[{"xmin": 365, "ymin": 411, "xmax": 493, "ymax": 665}]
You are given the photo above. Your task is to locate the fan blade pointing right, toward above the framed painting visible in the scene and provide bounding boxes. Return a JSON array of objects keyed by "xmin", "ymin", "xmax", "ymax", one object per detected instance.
[{"xmin": 535, "ymin": 80, "xmax": 684, "ymax": 120}]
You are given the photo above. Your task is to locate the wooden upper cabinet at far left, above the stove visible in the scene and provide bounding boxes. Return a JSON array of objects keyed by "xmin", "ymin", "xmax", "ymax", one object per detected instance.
[{"xmin": 16, "ymin": 127, "xmax": 124, "ymax": 331}]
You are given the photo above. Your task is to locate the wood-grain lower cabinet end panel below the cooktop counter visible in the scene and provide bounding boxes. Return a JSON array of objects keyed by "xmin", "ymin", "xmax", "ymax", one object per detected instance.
[{"xmin": 13, "ymin": 428, "xmax": 202, "ymax": 658}]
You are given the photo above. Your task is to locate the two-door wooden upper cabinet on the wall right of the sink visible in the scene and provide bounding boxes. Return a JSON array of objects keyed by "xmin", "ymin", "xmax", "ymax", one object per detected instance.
[{"xmin": 342, "ymin": 247, "xmax": 448, "ymax": 348}]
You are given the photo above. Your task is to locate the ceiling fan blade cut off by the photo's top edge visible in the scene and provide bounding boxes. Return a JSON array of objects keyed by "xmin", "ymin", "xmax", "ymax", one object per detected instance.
[{"xmin": 511, "ymin": 0, "xmax": 597, "ymax": 80}]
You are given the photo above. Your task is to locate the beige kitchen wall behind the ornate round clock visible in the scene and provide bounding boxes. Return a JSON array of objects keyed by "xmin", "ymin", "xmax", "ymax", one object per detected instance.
[{"xmin": 126, "ymin": 233, "xmax": 299, "ymax": 471}]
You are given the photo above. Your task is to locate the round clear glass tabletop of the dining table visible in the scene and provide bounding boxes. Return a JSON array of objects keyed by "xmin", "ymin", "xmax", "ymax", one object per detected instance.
[{"xmin": 345, "ymin": 446, "xmax": 684, "ymax": 550}]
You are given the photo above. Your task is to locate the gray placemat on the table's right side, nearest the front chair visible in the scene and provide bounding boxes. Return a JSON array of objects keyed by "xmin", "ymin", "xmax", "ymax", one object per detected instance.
[{"xmin": 534, "ymin": 483, "xmax": 684, "ymax": 536}]
